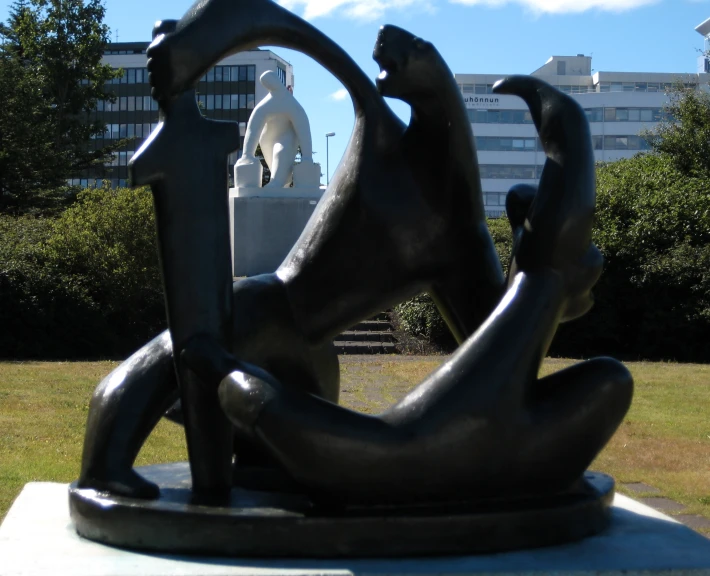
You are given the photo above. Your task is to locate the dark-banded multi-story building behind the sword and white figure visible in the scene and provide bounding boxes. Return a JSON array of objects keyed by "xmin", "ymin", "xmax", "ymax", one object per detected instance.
[{"xmin": 71, "ymin": 42, "xmax": 294, "ymax": 187}]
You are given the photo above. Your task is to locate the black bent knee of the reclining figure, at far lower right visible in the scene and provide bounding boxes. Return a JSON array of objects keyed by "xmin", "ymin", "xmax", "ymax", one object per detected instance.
[{"xmin": 520, "ymin": 358, "xmax": 633, "ymax": 489}]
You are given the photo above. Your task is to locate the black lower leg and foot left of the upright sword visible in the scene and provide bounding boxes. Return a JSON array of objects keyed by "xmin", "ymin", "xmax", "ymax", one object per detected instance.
[{"xmin": 79, "ymin": 331, "xmax": 178, "ymax": 498}]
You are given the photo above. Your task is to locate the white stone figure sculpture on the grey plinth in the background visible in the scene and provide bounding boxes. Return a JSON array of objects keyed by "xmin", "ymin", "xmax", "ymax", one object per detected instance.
[{"xmin": 234, "ymin": 70, "xmax": 320, "ymax": 189}]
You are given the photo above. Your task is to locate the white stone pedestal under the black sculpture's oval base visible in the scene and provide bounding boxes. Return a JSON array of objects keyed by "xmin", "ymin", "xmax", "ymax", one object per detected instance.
[{"xmin": 0, "ymin": 483, "xmax": 710, "ymax": 576}]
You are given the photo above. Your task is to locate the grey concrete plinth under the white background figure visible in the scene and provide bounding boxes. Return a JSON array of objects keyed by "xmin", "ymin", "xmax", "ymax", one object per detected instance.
[{"xmin": 229, "ymin": 194, "xmax": 322, "ymax": 276}]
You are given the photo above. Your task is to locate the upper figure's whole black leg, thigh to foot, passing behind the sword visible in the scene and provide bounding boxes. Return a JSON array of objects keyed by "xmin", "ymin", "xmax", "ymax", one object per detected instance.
[{"xmin": 79, "ymin": 275, "xmax": 339, "ymax": 498}]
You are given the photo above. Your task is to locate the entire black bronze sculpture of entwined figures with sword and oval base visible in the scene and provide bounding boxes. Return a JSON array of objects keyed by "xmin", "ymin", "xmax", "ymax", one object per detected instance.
[{"xmin": 71, "ymin": 0, "xmax": 632, "ymax": 555}]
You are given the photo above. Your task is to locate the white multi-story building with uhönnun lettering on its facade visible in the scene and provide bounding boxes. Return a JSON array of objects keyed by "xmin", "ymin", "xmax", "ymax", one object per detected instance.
[{"xmin": 455, "ymin": 20, "xmax": 710, "ymax": 217}]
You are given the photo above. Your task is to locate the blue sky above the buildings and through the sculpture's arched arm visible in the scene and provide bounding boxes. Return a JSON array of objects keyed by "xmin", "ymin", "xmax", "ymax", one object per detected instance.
[{"xmin": 0, "ymin": 0, "xmax": 710, "ymax": 178}]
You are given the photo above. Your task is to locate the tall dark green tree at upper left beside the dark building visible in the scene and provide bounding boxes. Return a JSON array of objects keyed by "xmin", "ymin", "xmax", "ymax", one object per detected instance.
[{"xmin": 0, "ymin": 0, "xmax": 122, "ymax": 211}]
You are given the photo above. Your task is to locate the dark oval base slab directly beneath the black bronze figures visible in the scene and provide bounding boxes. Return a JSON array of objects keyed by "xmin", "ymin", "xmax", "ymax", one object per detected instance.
[{"xmin": 69, "ymin": 463, "xmax": 614, "ymax": 558}]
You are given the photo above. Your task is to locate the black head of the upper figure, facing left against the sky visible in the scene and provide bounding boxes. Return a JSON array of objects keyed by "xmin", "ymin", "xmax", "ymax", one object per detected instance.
[{"xmin": 372, "ymin": 25, "xmax": 447, "ymax": 103}]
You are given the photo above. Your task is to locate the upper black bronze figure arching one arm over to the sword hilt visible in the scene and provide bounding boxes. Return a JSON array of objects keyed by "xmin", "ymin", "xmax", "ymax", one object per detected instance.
[{"xmin": 80, "ymin": 0, "xmax": 504, "ymax": 496}]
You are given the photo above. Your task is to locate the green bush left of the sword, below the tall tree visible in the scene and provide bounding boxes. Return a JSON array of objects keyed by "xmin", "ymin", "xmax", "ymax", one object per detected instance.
[{"xmin": 0, "ymin": 188, "xmax": 165, "ymax": 358}]
